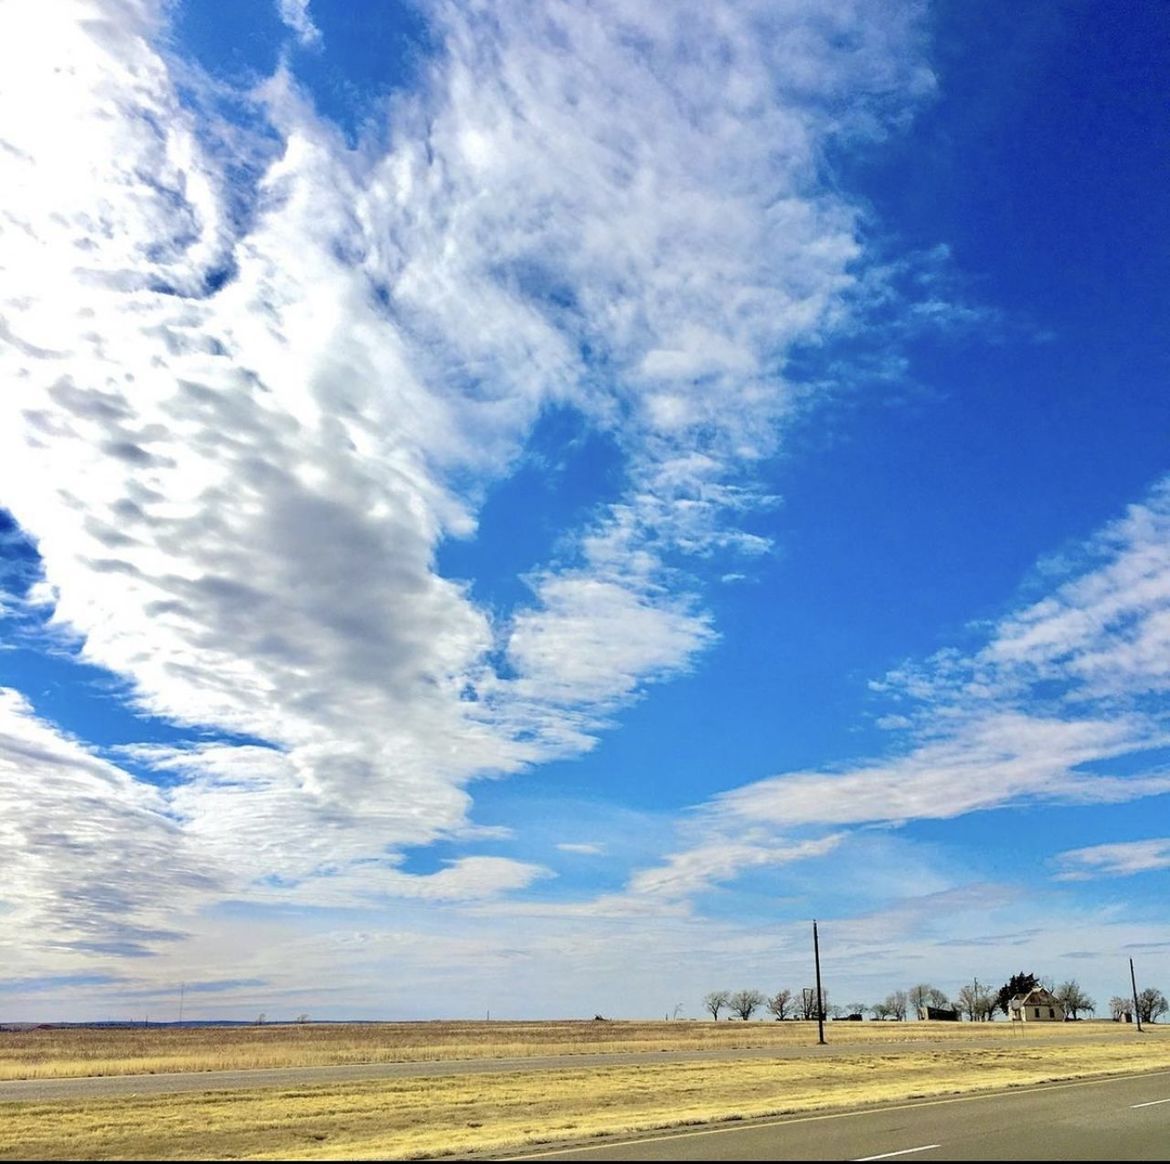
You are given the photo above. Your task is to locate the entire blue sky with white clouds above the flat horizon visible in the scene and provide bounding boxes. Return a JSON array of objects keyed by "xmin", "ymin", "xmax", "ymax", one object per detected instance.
[{"xmin": 0, "ymin": 0, "xmax": 1170, "ymax": 1021}]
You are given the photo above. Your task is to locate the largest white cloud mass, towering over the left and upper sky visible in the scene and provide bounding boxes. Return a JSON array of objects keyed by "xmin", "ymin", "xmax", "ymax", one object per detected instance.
[{"xmin": 0, "ymin": 0, "xmax": 929, "ymax": 926}]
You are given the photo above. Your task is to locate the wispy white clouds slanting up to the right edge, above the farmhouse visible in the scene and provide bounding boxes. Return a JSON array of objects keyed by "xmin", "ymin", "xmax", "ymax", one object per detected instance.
[{"xmin": 627, "ymin": 482, "xmax": 1170, "ymax": 894}]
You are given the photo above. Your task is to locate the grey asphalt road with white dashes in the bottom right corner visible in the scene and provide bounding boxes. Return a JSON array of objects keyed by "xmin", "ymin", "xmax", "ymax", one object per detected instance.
[{"xmin": 493, "ymin": 1072, "xmax": 1170, "ymax": 1162}]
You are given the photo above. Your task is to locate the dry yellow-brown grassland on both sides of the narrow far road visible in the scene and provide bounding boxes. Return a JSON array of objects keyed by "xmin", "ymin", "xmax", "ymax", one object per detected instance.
[{"xmin": 0, "ymin": 1020, "xmax": 1170, "ymax": 1159}]
